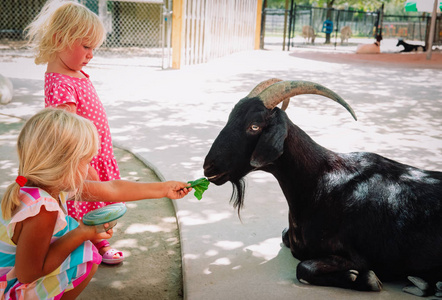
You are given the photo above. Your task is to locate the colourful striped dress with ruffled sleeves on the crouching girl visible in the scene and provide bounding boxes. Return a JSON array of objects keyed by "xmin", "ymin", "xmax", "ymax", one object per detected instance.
[{"xmin": 0, "ymin": 187, "xmax": 101, "ymax": 299}]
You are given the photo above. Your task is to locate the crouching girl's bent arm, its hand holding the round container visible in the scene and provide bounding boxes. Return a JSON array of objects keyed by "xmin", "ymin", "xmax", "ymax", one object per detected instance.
[{"xmin": 12, "ymin": 206, "xmax": 113, "ymax": 283}]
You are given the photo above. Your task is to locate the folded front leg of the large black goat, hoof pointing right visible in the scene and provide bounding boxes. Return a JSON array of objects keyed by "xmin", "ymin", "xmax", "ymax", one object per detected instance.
[{"xmin": 296, "ymin": 256, "xmax": 382, "ymax": 292}]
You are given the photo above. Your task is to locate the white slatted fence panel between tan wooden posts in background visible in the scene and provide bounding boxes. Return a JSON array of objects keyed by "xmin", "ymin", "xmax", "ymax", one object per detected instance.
[{"xmin": 172, "ymin": 0, "xmax": 262, "ymax": 69}]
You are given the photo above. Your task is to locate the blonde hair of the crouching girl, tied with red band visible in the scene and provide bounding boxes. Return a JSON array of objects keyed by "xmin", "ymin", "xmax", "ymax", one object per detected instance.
[{"xmin": 1, "ymin": 108, "xmax": 98, "ymax": 220}]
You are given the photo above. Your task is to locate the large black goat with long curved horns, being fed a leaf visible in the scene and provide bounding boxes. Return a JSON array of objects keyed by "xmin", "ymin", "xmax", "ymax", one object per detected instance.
[{"xmin": 204, "ymin": 79, "xmax": 442, "ymax": 294}]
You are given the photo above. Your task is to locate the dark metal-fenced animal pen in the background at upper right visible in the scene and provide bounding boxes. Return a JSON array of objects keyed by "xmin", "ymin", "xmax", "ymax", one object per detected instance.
[{"xmin": 261, "ymin": 4, "xmax": 442, "ymax": 50}]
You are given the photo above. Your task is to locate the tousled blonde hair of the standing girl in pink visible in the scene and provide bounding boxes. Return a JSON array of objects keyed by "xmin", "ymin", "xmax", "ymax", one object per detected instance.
[{"xmin": 25, "ymin": 0, "xmax": 106, "ymax": 64}]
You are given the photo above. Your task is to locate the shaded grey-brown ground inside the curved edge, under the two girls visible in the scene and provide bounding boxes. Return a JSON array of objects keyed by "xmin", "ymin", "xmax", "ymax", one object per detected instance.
[{"xmin": 0, "ymin": 114, "xmax": 183, "ymax": 300}]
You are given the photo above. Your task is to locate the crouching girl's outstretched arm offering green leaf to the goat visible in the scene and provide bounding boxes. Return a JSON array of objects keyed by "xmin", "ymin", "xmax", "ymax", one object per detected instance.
[{"xmin": 81, "ymin": 180, "xmax": 192, "ymax": 202}]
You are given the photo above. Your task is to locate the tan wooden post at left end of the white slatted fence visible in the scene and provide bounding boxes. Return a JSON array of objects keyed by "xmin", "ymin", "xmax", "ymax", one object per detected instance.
[{"xmin": 172, "ymin": 0, "xmax": 184, "ymax": 69}]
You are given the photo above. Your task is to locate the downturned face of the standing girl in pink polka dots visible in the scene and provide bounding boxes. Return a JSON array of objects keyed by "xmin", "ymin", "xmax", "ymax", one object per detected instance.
[{"xmin": 58, "ymin": 39, "xmax": 94, "ymax": 72}]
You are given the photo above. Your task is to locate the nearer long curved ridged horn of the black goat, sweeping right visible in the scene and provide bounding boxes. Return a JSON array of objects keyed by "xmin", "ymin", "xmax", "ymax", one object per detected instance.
[{"xmin": 257, "ymin": 81, "xmax": 357, "ymax": 120}]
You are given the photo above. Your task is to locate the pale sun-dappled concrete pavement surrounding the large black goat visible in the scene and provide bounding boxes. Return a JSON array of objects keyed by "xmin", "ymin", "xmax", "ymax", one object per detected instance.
[{"xmin": 0, "ymin": 45, "xmax": 442, "ymax": 300}]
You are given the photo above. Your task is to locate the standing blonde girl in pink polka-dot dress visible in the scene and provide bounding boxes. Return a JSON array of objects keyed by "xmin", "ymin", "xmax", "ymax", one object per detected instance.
[{"xmin": 27, "ymin": 0, "xmax": 129, "ymax": 264}]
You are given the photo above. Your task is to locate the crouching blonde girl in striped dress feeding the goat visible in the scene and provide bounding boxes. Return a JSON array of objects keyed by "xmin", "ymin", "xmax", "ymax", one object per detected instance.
[{"xmin": 0, "ymin": 108, "xmax": 191, "ymax": 300}]
